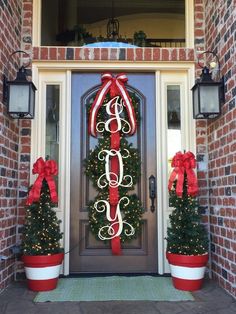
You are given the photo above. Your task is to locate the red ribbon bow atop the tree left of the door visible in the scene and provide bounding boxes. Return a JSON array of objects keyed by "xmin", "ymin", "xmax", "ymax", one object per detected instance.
[{"xmin": 26, "ymin": 157, "xmax": 58, "ymax": 205}]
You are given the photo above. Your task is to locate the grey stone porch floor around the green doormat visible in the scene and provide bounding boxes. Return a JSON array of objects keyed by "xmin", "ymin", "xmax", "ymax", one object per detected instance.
[{"xmin": 0, "ymin": 280, "xmax": 236, "ymax": 314}]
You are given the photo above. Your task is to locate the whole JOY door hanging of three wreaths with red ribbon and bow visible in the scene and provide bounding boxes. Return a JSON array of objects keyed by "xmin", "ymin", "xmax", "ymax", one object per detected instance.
[{"xmin": 85, "ymin": 74, "xmax": 143, "ymax": 255}]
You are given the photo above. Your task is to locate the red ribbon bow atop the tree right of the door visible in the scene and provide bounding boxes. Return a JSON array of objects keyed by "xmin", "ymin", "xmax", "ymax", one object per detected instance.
[{"xmin": 168, "ymin": 152, "xmax": 198, "ymax": 197}]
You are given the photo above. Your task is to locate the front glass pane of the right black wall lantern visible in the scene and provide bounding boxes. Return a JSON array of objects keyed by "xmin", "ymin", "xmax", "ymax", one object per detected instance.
[{"xmin": 200, "ymin": 85, "xmax": 220, "ymax": 113}]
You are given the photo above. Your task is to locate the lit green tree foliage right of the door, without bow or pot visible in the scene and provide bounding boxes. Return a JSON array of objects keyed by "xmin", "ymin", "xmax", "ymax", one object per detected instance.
[{"xmin": 167, "ymin": 153, "xmax": 208, "ymax": 255}]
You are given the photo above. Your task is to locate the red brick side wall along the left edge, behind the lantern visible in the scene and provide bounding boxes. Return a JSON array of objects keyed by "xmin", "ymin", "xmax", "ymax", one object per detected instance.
[{"xmin": 0, "ymin": 0, "xmax": 22, "ymax": 290}]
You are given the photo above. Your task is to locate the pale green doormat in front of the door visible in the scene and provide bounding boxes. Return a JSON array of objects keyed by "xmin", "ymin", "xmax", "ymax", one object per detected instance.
[{"xmin": 34, "ymin": 276, "xmax": 194, "ymax": 302}]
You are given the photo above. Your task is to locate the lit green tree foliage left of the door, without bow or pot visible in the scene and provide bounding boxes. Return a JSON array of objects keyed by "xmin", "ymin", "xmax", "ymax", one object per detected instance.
[{"xmin": 22, "ymin": 179, "xmax": 63, "ymax": 255}]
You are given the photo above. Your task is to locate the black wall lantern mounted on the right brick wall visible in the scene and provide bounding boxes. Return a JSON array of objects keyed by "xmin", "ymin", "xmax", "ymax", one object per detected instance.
[{"xmin": 192, "ymin": 51, "xmax": 225, "ymax": 119}]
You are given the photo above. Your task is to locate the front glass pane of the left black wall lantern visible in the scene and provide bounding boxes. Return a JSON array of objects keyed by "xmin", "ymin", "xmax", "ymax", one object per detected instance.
[{"xmin": 8, "ymin": 84, "xmax": 29, "ymax": 113}]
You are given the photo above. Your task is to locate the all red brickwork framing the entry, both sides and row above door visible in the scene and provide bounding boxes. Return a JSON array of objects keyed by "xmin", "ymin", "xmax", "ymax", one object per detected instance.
[{"xmin": 0, "ymin": 0, "xmax": 236, "ymax": 294}]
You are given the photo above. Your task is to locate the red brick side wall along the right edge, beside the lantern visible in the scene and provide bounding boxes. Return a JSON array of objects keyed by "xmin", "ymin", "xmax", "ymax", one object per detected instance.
[{"xmin": 205, "ymin": 0, "xmax": 236, "ymax": 295}]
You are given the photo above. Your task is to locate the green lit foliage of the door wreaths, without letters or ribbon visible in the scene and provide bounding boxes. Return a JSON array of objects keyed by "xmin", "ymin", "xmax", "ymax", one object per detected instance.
[{"xmin": 84, "ymin": 93, "xmax": 144, "ymax": 243}]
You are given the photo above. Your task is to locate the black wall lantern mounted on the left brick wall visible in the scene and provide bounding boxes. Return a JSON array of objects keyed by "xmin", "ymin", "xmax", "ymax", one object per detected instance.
[{"xmin": 3, "ymin": 50, "xmax": 36, "ymax": 119}]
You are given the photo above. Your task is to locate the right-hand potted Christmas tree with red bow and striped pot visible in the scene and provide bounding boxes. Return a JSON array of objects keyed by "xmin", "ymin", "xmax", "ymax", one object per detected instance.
[{"xmin": 166, "ymin": 152, "xmax": 208, "ymax": 291}]
